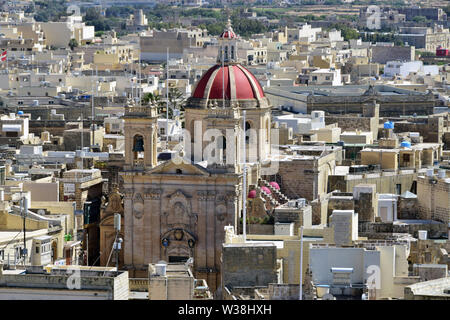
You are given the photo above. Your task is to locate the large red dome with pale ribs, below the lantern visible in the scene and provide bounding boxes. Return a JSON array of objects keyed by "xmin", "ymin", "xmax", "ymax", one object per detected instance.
[{"xmin": 192, "ymin": 65, "xmax": 264, "ymax": 100}]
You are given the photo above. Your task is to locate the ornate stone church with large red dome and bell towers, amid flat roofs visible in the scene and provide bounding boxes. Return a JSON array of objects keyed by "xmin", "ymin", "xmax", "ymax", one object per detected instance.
[{"xmin": 121, "ymin": 24, "xmax": 271, "ymax": 291}]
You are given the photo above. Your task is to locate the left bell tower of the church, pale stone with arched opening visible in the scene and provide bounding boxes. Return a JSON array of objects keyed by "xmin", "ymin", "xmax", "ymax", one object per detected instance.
[{"xmin": 123, "ymin": 106, "xmax": 158, "ymax": 171}]
